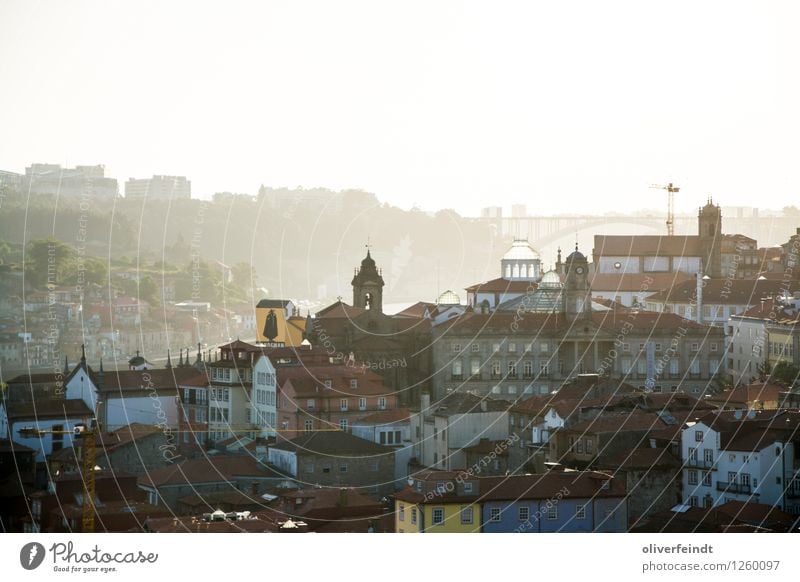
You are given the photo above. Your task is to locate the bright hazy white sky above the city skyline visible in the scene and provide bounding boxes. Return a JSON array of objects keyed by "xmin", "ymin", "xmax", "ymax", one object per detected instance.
[{"xmin": 0, "ymin": 0, "xmax": 800, "ymax": 214}]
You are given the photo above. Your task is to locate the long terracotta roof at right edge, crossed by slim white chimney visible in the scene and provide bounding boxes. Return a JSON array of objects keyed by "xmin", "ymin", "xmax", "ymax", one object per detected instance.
[{"xmin": 647, "ymin": 279, "xmax": 800, "ymax": 305}]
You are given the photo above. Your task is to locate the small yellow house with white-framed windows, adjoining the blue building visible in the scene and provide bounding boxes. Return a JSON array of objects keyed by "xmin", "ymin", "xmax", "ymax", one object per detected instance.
[{"xmin": 394, "ymin": 471, "xmax": 481, "ymax": 533}]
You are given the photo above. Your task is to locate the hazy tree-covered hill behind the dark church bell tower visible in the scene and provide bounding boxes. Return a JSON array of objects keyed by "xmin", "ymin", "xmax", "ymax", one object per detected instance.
[{"xmin": 0, "ymin": 189, "xmax": 500, "ymax": 303}]
